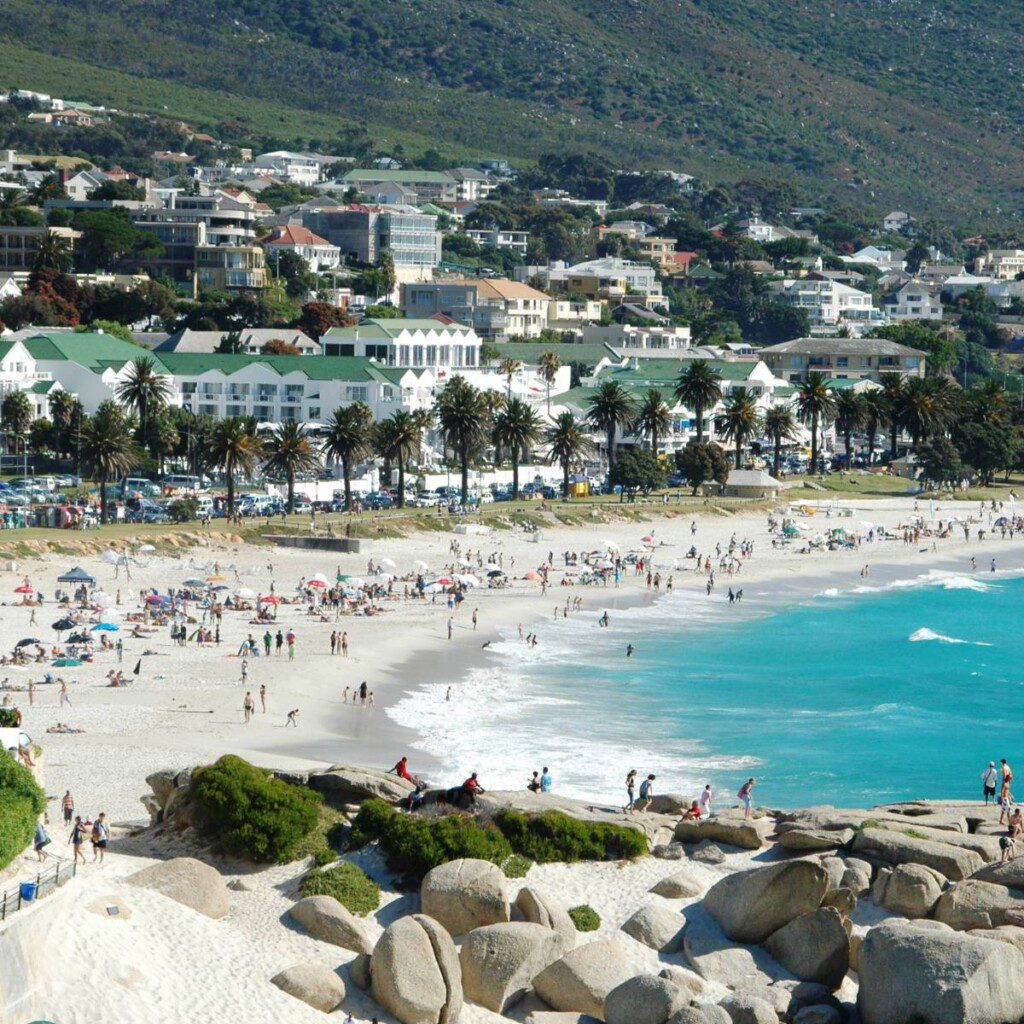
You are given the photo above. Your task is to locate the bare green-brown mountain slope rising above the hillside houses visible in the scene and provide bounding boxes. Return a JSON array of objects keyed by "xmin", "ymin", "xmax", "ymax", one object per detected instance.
[{"xmin": 0, "ymin": 0, "xmax": 1024, "ymax": 220}]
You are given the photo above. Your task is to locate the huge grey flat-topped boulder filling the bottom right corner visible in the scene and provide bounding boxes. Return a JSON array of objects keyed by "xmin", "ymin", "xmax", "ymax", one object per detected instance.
[{"xmin": 857, "ymin": 921, "xmax": 1024, "ymax": 1024}]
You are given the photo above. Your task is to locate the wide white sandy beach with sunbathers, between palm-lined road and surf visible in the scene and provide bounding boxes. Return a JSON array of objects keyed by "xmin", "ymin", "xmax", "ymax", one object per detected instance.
[{"xmin": 8, "ymin": 489, "xmax": 1024, "ymax": 823}]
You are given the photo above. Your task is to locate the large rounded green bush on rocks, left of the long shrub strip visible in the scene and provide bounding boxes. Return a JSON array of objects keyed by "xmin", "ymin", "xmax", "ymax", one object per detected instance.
[{"xmin": 191, "ymin": 754, "xmax": 321, "ymax": 864}]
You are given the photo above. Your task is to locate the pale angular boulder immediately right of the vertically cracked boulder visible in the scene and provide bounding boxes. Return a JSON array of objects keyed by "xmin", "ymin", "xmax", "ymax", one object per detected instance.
[{"xmin": 459, "ymin": 921, "xmax": 562, "ymax": 1014}]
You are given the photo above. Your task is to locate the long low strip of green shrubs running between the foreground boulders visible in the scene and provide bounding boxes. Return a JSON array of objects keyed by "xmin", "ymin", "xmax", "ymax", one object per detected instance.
[{"xmin": 349, "ymin": 800, "xmax": 647, "ymax": 881}]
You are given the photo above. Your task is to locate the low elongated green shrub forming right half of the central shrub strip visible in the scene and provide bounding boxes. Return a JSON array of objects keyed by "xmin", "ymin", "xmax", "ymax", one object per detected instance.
[{"xmin": 495, "ymin": 811, "xmax": 647, "ymax": 864}]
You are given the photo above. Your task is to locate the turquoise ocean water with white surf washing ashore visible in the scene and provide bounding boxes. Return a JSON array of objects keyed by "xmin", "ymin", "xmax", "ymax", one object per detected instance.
[{"xmin": 389, "ymin": 571, "xmax": 1024, "ymax": 806}]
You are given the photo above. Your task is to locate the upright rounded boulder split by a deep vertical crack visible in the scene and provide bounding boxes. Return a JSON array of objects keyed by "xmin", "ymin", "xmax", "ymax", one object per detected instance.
[{"xmin": 370, "ymin": 913, "xmax": 463, "ymax": 1024}]
